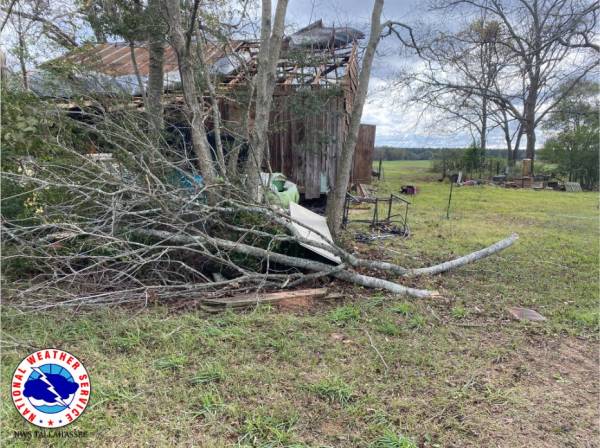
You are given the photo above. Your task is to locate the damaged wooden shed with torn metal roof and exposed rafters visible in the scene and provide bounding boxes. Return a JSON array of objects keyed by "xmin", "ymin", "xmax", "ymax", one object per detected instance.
[{"xmin": 32, "ymin": 20, "xmax": 375, "ymax": 199}]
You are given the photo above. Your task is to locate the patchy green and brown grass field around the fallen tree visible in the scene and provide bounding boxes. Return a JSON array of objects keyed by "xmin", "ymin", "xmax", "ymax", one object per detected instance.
[{"xmin": 0, "ymin": 162, "xmax": 599, "ymax": 448}]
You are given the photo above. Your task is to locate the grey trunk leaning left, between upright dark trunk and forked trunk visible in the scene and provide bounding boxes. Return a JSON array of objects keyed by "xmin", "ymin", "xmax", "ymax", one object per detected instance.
[{"xmin": 166, "ymin": 0, "xmax": 216, "ymax": 185}]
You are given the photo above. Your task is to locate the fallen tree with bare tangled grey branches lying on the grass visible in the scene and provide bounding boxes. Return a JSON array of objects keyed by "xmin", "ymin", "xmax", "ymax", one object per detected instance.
[{"xmin": 2, "ymin": 111, "xmax": 518, "ymax": 309}]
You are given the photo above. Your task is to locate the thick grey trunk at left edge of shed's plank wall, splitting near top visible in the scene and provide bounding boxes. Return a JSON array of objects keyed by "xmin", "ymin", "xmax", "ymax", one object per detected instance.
[{"xmin": 244, "ymin": 0, "xmax": 288, "ymax": 201}]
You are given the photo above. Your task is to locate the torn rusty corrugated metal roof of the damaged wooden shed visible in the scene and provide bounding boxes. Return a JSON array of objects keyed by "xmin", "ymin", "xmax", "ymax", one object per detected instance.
[{"xmin": 30, "ymin": 21, "xmax": 362, "ymax": 98}]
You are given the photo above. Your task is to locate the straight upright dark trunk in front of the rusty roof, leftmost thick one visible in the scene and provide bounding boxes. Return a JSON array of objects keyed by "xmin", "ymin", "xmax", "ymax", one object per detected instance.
[{"xmin": 146, "ymin": 0, "xmax": 165, "ymax": 137}]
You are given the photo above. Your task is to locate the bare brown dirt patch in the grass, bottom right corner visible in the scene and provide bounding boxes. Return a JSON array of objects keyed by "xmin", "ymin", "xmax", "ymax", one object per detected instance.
[{"xmin": 481, "ymin": 336, "xmax": 600, "ymax": 448}]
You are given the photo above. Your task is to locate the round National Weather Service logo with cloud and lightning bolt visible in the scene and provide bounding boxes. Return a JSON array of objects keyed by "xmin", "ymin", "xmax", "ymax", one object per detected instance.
[{"xmin": 11, "ymin": 348, "xmax": 91, "ymax": 428}]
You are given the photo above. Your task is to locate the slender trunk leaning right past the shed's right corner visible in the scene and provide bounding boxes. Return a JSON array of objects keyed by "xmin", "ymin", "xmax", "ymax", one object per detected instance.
[{"xmin": 327, "ymin": 0, "xmax": 383, "ymax": 238}]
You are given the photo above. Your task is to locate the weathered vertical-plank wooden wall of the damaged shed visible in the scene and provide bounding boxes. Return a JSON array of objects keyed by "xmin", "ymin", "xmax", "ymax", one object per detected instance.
[{"xmin": 221, "ymin": 45, "xmax": 375, "ymax": 199}]
